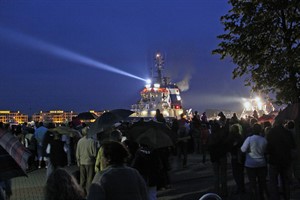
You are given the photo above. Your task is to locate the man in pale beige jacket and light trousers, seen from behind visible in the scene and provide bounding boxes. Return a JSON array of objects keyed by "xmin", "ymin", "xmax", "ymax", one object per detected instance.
[{"xmin": 76, "ymin": 127, "xmax": 97, "ymax": 194}]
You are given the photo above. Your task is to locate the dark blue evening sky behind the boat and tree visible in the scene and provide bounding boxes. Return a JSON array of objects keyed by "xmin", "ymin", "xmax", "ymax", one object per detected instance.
[{"xmin": 0, "ymin": 0, "xmax": 249, "ymax": 114}]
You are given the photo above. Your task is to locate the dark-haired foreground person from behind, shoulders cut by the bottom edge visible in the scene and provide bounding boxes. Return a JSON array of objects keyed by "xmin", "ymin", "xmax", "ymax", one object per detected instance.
[{"xmin": 87, "ymin": 141, "xmax": 148, "ymax": 200}]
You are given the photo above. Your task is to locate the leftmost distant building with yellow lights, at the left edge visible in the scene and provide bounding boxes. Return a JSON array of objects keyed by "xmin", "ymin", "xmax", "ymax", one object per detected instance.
[{"xmin": 0, "ymin": 110, "xmax": 28, "ymax": 124}]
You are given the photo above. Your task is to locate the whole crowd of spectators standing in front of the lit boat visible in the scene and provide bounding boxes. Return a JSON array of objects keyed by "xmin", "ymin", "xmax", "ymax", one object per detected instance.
[{"xmin": 0, "ymin": 110, "xmax": 300, "ymax": 200}]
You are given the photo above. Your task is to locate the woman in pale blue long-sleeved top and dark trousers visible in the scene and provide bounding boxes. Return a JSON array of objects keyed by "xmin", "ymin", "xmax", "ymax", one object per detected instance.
[{"xmin": 241, "ymin": 123, "xmax": 268, "ymax": 200}]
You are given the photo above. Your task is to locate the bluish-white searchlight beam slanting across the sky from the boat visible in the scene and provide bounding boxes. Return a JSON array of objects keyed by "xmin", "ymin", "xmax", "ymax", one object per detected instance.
[{"xmin": 0, "ymin": 27, "xmax": 147, "ymax": 82}]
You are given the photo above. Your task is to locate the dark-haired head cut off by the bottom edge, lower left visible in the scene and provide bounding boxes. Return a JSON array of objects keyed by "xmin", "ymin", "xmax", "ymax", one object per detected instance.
[{"xmin": 45, "ymin": 168, "xmax": 85, "ymax": 200}]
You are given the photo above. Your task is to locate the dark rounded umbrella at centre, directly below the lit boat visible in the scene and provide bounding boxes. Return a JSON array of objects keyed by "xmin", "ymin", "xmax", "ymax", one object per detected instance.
[{"xmin": 128, "ymin": 121, "xmax": 177, "ymax": 149}]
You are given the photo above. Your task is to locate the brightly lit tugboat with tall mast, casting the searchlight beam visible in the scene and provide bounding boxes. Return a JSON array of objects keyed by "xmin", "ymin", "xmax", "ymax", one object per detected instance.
[{"xmin": 131, "ymin": 53, "xmax": 183, "ymax": 118}]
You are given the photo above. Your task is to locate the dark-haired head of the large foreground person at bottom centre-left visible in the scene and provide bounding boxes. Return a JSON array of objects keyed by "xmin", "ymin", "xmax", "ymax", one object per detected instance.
[{"xmin": 100, "ymin": 140, "xmax": 130, "ymax": 170}]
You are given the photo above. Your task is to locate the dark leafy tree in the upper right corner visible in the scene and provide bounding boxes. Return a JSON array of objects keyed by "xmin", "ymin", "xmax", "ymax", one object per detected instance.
[{"xmin": 213, "ymin": 0, "xmax": 300, "ymax": 104}]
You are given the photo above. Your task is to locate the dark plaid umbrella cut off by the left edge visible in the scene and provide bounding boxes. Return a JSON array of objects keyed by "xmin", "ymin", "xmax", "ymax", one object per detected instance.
[{"xmin": 0, "ymin": 129, "xmax": 31, "ymax": 180}]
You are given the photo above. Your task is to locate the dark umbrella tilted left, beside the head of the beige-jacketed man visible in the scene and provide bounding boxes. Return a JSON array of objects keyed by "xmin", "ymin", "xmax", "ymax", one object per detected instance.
[{"xmin": 88, "ymin": 109, "xmax": 134, "ymax": 136}]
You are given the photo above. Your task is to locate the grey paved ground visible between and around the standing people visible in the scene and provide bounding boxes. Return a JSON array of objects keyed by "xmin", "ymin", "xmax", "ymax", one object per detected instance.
[{"xmin": 11, "ymin": 155, "xmax": 300, "ymax": 200}]
